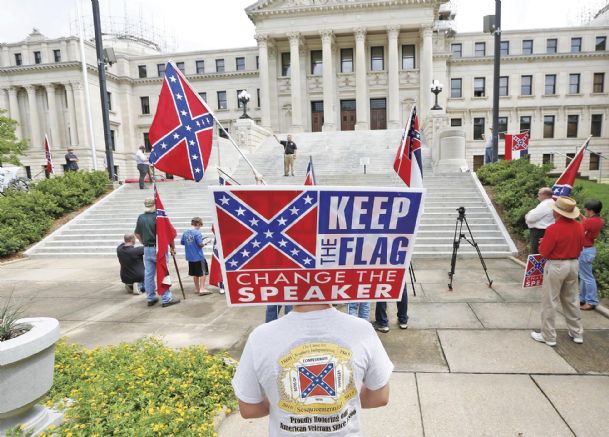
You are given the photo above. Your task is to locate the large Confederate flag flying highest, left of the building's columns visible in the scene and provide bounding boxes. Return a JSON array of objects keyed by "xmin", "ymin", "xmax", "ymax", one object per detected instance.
[{"xmin": 149, "ymin": 62, "xmax": 214, "ymax": 182}]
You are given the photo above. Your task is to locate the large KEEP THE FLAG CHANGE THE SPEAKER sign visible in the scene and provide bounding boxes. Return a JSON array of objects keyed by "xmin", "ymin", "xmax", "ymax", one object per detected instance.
[{"xmin": 210, "ymin": 186, "xmax": 424, "ymax": 305}]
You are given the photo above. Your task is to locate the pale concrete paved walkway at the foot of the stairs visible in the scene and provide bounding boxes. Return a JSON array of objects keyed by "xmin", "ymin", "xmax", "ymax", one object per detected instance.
[{"xmin": 0, "ymin": 258, "xmax": 609, "ymax": 437}]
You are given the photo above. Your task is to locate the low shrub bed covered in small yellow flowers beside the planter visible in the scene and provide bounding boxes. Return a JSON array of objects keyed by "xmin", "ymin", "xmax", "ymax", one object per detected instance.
[{"xmin": 36, "ymin": 338, "xmax": 236, "ymax": 437}]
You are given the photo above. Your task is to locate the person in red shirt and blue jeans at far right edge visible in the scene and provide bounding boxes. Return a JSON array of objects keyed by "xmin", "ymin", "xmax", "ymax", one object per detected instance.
[{"xmin": 579, "ymin": 200, "xmax": 605, "ymax": 311}]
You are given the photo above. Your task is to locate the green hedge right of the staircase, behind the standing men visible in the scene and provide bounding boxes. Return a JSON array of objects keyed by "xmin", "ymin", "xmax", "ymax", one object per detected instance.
[{"xmin": 477, "ymin": 159, "xmax": 609, "ymax": 297}]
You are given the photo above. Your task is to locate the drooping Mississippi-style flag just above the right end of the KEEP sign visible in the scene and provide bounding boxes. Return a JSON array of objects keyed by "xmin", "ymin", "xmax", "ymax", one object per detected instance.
[{"xmin": 393, "ymin": 106, "xmax": 423, "ymax": 188}]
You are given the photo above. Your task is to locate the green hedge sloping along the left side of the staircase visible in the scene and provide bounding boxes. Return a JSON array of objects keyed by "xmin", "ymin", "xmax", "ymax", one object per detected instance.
[{"xmin": 0, "ymin": 171, "xmax": 108, "ymax": 257}]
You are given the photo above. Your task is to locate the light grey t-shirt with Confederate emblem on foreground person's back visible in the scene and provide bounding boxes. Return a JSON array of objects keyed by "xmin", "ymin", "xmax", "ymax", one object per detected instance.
[{"xmin": 233, "ymin": 308, "xmax": 393, "ymax": 437}]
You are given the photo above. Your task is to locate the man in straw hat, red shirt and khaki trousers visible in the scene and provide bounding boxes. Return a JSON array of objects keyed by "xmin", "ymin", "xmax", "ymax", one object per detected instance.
[{"xmin": 531, "ymin": 196, "xmax": 584, "ymax": 346}]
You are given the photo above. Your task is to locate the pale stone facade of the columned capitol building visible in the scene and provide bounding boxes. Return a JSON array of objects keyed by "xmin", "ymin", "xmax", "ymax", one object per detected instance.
[{"xmin": 0, "ymin": 0, "xmax": 609, "ymax": 178}]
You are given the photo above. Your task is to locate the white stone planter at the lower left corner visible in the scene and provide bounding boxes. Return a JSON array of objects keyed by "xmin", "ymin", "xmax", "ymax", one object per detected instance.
[{"xmin": 0, "ymin": 317, "xmax": 63, "ymax": 435}]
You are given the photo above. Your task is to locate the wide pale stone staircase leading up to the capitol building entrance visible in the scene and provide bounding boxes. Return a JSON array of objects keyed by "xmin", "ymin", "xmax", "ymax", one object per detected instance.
[{"xmin": 26, "ymin": 130, "xmax": 516, "ymax": 257}]
